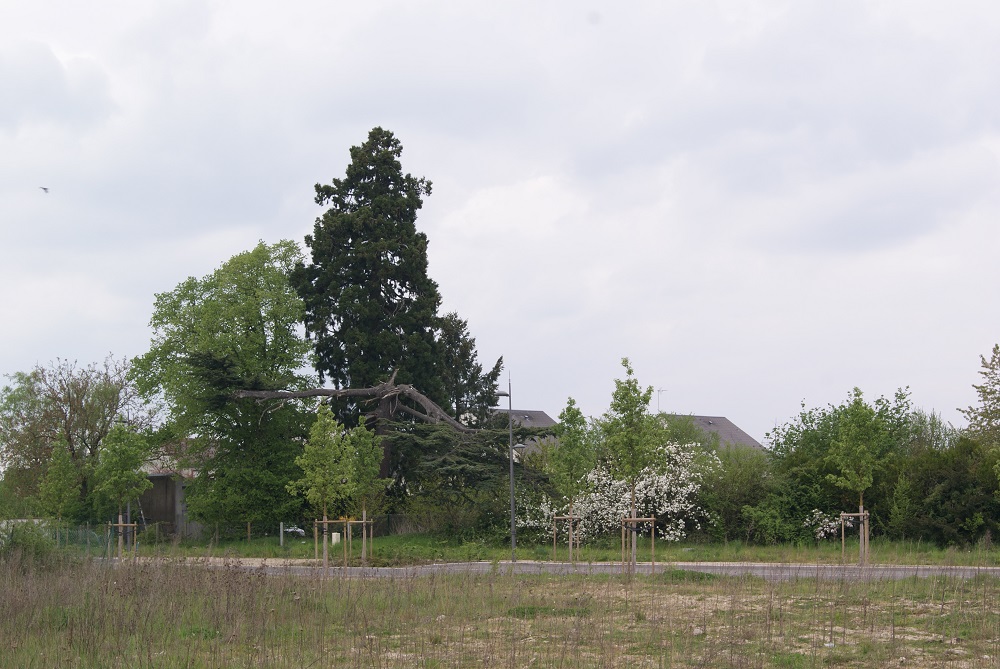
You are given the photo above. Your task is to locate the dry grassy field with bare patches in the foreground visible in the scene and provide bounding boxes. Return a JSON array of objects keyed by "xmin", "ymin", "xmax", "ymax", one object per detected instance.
[{"xmin": 0, "ymin": 559, "xmax": 1000, "ymax": 669}]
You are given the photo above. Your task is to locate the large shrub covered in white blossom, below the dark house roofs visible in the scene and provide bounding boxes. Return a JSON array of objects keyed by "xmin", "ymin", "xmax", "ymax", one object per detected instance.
[{"xmin": 518, "ymin": 444, "xmax": 719, "ymax": 541}]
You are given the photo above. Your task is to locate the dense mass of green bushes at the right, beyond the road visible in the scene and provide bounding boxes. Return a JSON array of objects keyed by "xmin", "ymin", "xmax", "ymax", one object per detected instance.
[{"xmin": 756, "ymin": 384, "xmax": 1000, "ymax": 546}]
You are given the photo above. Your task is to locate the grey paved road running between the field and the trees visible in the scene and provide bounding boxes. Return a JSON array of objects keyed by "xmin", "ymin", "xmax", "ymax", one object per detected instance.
[{"xmin": 203, "ymin": 561, "xmax": 1000, "ymax": 581}]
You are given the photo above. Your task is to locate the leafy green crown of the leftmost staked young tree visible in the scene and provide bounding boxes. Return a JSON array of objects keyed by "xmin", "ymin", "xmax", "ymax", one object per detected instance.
[{"xmin": 94, "ymin": 424, "xmax": 153, "ymax": 515}]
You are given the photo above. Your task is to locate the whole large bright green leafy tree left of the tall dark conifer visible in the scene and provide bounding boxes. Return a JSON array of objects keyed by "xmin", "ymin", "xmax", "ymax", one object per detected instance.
[{"xmin": 135, "ymin": 241, "xmax": 314, "ymax": 525}]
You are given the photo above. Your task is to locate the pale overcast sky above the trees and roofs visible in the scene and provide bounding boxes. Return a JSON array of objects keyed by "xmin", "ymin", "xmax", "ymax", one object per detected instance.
[{"xmin": 0, "ymin": 0, "xmax": 1000, "ymax": 441}]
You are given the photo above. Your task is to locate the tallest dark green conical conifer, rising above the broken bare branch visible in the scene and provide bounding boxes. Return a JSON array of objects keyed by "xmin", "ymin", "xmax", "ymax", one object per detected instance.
[{"xmin": 292, "ymin": 128, "xmax": 443, "ymax": 403}]
